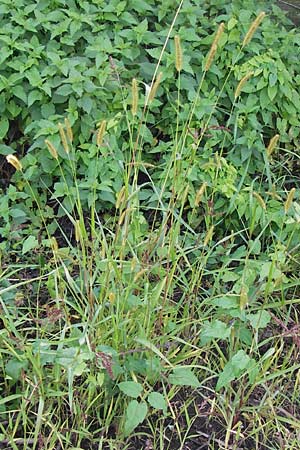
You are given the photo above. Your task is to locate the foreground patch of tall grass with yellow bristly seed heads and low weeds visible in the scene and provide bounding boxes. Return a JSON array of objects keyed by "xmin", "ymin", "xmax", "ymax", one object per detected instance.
[{"xmin": 0, "ymin": 1, "xmax": 300, "ymax": 450}]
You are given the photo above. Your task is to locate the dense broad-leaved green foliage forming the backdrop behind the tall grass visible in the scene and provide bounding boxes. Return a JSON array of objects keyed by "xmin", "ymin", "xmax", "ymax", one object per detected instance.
[{"xmin": 0, "ymin": 1, "xmax": 300, "ymax": 249}]
